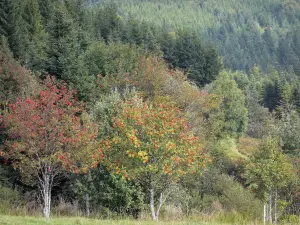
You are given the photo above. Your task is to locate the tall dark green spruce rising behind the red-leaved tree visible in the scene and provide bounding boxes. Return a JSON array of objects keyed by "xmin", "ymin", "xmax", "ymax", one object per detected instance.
[{"xmin": 46, "ymin": 0, "xmax": 96, "ymax": 101}]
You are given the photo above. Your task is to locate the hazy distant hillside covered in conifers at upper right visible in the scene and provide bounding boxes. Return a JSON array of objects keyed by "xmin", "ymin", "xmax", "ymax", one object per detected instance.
[{"xmin": 96, "ymin": 0, "xmax": 300, "ymax": 75}]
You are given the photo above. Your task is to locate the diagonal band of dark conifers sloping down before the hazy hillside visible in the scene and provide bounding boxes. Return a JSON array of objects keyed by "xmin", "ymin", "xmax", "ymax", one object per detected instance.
[{"xmin": 90, "ymin": 3, "xmax": 221, "ymax": 86}]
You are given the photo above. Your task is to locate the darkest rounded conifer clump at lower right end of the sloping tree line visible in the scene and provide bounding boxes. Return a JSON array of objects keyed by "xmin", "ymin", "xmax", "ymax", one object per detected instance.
[{"xmin": 161, "ymin": 30, "xmax": 221, "ymax": 86}]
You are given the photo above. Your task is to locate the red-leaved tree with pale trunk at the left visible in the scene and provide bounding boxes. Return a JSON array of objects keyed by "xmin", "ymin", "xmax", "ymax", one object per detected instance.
[{"xmin": 1, "ymin": 77, "xmax": 103, "ymax": 218}]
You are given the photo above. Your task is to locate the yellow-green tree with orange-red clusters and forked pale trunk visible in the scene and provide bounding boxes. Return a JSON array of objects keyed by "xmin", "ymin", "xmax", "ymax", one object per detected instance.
[{"xmin": 103, "ymin": 96, "xmax": 209, "ymax": 221}]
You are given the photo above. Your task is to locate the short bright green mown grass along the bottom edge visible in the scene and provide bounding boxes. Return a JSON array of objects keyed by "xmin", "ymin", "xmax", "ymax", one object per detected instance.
[{"xmin": 0, "ymin": 215, "xmax": 239, "ymax": 225}]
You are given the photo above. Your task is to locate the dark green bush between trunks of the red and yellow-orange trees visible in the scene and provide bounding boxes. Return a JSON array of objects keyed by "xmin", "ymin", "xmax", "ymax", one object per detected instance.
[{"xmin": 73, "ymin": 165, "xmax": 144, "ymax": 216}]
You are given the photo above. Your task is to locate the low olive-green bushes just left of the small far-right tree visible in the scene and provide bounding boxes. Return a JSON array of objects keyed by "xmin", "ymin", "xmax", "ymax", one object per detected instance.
[{"xmin": 182, "ymin": 168, "xmax": 262, "ymax": 220}]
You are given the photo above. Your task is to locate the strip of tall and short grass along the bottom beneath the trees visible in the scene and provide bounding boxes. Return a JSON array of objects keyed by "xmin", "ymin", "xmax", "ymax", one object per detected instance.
[{"xmin": 0, "ymin": 187, "xmax": 300, "ymax": 225}]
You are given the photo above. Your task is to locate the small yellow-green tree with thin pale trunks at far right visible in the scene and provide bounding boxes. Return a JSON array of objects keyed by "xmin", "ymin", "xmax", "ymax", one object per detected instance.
[{"xmin": 245, "ymin": 137, "xmax": 294, "ymax": 223}]
